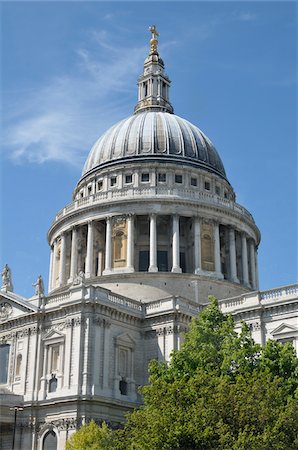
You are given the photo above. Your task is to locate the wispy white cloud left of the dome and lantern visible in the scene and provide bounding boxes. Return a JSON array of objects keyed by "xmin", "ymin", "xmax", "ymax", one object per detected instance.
[{"xmin": 2, "ymin": 31, "xmax": 145, "ymax": 166}]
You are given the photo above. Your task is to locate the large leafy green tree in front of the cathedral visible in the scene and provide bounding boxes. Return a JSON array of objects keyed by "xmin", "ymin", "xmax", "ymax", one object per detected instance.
[{"xmin": 67, "ymin": 297, "xmax": 298, "ymax": 450}]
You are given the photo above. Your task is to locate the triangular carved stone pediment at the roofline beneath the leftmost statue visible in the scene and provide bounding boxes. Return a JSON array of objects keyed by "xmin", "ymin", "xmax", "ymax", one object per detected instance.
[{"xmin": 0, "ymin": 291, "xmax": 38, "ymax": 323}]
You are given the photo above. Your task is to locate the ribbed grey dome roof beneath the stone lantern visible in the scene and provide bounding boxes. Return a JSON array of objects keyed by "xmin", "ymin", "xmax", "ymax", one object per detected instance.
[{"xmin": 82, "ymin": 110, "xmax": 226, "ymax": 178}]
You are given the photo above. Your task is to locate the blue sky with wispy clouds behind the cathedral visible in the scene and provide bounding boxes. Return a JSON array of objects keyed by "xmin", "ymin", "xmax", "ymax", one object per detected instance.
[{"xmin": 0, "ymin": 1, "xmax": 297, "ymax": 297}]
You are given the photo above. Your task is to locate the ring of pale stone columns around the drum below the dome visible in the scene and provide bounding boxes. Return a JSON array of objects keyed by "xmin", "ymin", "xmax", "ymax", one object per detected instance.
[{"xmin": 49, "ymin": 214, "xmax": 258, "ymax": 290}]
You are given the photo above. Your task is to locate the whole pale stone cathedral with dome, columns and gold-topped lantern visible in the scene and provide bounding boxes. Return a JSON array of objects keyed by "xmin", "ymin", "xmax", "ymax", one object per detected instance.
[{"xmin": 0, "ymin": 27, "xmax": 298, "ymax": 450}]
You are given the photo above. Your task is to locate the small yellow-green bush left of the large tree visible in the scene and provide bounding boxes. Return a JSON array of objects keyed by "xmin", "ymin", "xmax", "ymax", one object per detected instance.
[{"xmin": 66, "ymin": 420, "xmax": 114, "ymax": 450}]
